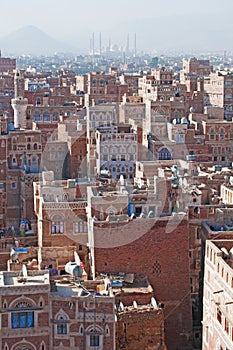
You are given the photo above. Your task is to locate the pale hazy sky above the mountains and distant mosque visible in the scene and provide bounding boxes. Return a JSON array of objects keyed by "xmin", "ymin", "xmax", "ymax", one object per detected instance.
[{"xmin": 0, "ymin": 0, "xmax": 233, "ymax": 52}]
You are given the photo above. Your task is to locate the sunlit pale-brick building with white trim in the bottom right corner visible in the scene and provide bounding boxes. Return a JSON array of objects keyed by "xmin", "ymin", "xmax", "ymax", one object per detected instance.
[{"xmin": 202, "ymin": 237, "xmax": 233, "ymax": 350}]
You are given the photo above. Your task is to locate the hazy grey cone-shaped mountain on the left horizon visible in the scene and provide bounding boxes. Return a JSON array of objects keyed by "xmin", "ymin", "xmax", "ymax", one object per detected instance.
[{"xmin": 0, "ymin": 26, "xmax": 78, "ymax": 56}]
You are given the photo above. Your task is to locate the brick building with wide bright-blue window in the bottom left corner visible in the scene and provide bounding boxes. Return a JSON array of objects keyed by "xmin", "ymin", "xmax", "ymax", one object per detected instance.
[{"xmin": 0, "ymin": 271, "xmax": 50, "ymax": 350}]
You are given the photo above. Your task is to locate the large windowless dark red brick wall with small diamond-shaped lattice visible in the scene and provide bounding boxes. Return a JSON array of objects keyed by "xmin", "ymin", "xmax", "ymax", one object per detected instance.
[{"xmin": 90, "ymin": 215, "xmax": 192, "ymax": 349}]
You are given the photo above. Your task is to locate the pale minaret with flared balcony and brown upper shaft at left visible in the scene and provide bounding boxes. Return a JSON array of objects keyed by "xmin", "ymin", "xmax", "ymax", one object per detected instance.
[{"xmin": 11, "ymin": 71, "xmax": 28, "ymax": 129}]
